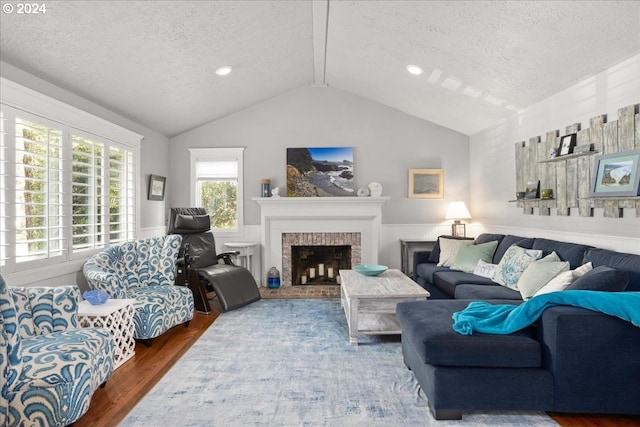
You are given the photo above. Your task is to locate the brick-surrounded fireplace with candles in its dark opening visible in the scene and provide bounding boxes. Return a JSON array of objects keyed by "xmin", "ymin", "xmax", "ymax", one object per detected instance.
[{"xmin": 282, "ymin": 233, "xmax": 362, "ymax": 286}]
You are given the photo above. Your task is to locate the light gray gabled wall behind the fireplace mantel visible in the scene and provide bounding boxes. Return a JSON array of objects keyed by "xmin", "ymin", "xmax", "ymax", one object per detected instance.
[{"xmin": 169, "ymin": 87, "xmax": 469, "ymax": 225}]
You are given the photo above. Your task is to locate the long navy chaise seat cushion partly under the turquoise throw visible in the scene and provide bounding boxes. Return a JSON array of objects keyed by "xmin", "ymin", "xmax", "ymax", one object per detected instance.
[{"xmin": 396, "ymin": 300, "xmax": 542, "ymax": 368}]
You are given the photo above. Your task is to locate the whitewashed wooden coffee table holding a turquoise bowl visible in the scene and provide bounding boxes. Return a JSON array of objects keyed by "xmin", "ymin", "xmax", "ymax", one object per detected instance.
[{"xmin": 340, "ymin": 269, "xmax": 430, "ymax": 345}]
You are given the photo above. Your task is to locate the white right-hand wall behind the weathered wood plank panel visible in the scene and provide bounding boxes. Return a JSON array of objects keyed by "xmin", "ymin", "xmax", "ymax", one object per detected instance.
[{"xmin": 470, "ymin": 55, "xmax": 640, "ymax": 253}]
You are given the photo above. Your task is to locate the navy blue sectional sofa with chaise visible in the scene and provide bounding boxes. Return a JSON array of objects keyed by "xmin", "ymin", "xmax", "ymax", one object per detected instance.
[{"xmin": 396, "ymin": 234, "xmax": 640, "ymax": 419}]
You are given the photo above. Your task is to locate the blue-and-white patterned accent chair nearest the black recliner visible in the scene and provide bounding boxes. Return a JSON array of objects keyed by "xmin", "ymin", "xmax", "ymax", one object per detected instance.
[{"xmin": 82, "ymin": 235, "xmax": 195, "ymax": 340}]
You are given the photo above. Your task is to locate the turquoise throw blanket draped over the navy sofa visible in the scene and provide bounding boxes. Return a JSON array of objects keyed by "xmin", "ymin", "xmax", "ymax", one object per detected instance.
[{"xmin": 453, "ymin": 291, "xmax": 640, "ymax": 335}]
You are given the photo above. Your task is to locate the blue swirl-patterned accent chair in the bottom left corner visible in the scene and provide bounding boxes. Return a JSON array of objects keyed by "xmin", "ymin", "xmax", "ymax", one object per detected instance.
[{"xmin": 0, "ymin": 276, "xmax": 115, "ymax": 426}]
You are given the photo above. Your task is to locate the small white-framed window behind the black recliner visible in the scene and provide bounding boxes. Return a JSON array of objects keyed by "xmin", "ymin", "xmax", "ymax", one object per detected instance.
[{"xmin": 189, "ymin": 148, "xmax": 244, "ymax": 233}]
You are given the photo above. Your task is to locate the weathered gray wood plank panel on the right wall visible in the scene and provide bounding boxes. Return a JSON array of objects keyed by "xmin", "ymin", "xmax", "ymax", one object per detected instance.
[{"xmin": 515, "ymin": 104, "xmax": 640, "ymax": 218}]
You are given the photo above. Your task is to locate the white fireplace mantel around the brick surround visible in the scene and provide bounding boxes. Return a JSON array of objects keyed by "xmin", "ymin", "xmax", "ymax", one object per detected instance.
[{"xmin": 253, "ymin": 197, "xmax": 389, "ymax": 281}]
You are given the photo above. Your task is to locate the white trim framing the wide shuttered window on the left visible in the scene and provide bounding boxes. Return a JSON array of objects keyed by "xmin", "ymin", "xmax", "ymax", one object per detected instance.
[{"xmin": 0, "ymin": 77, "xmax": 143, "ymax": 282}]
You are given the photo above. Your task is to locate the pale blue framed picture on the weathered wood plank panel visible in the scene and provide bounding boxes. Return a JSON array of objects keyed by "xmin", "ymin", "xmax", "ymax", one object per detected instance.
[{"xmin": 591, "ymin": 150, "xmax": 640, "ymax": 197}]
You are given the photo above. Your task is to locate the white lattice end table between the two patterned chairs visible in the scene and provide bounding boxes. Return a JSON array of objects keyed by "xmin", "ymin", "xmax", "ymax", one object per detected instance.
[{"xmin": 78, "ymin": 299, "xmax": 136, "ymax": 369}]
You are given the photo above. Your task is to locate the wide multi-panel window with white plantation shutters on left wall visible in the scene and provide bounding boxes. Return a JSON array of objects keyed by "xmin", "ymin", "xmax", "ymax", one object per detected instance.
[{"xmin": 0, "ymin": 79, "xmax": 140, "ymax": 273}]
